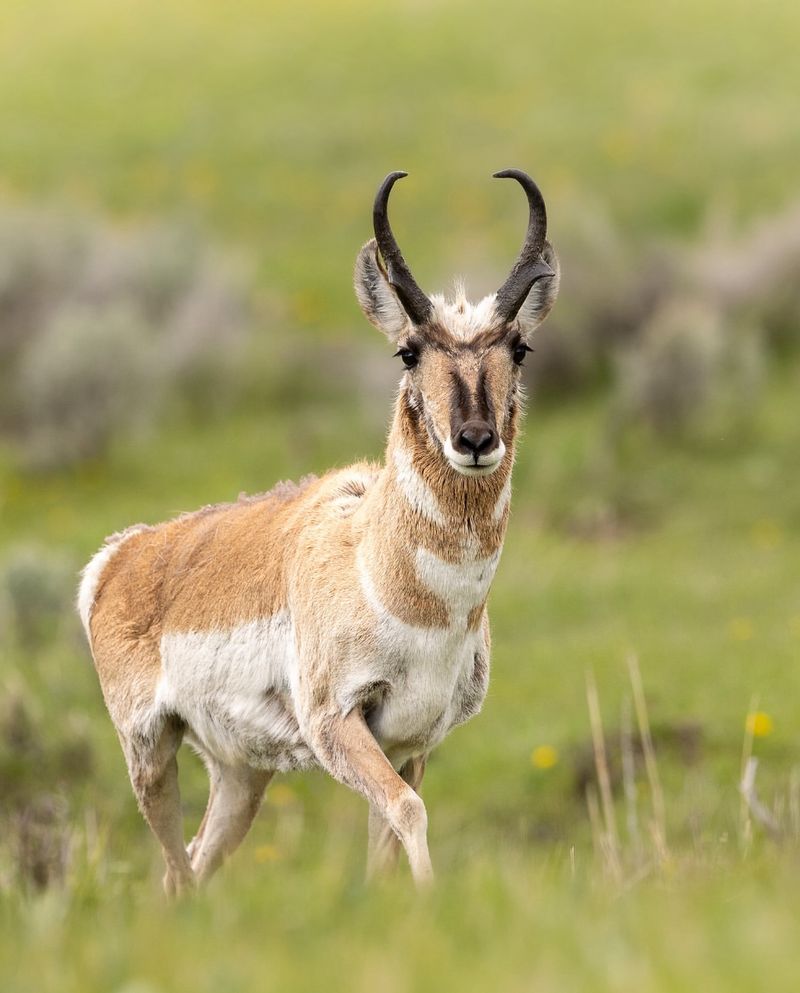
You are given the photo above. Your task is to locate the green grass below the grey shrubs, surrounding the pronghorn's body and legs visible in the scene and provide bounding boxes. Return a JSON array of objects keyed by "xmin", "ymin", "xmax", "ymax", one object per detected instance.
[{"xmin": 0, "ymin": 367, "xmax": 800, "ymax": 991}]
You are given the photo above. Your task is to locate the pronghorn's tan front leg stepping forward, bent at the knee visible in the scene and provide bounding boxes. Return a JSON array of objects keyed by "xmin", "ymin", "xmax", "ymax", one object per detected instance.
[{"xmin": 308, "ymin": 708, "xmax": 433, "ymax": 886}]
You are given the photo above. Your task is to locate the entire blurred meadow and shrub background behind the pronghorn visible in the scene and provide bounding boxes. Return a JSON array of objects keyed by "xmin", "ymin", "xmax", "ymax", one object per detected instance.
[{"xmin": 0, "ymin": 0, "xmax": 800, "ymax": 993}]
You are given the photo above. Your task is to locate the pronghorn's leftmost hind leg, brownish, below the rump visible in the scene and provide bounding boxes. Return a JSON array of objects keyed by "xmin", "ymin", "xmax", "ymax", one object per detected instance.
[{"xmin": 123, "ymin": 721, "xmax": 195, "ymax": 897}]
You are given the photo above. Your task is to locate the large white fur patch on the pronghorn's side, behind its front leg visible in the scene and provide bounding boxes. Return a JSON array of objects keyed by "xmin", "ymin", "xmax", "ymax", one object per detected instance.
[{"xmin": 157, "ymin": 610, "xmax": 313, "ymax": 769}]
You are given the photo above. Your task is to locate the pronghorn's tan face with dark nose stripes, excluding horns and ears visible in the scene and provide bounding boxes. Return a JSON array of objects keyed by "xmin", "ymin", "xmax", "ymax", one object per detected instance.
[{"xmin": 397, "ymin": 326, "xmax": 529, "ymax": 476}]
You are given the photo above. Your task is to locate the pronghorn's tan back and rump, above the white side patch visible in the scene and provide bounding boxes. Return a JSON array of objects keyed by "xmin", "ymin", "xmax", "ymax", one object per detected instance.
[{"xmin": 83, "ymin": 465, "xmax": 374, "ymax": 727}]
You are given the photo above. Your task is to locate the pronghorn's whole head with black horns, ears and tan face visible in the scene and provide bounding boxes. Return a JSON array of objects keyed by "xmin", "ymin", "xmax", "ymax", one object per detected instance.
[{"xmin": 355, "ymin": 169, "xmax": 560, "ymax": 476}]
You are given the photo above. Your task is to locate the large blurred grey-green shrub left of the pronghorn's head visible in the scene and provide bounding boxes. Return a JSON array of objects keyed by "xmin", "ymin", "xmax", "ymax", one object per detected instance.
[{"xmin": 0, "ymin": 206, "xmax": 249, "ymax": 468}]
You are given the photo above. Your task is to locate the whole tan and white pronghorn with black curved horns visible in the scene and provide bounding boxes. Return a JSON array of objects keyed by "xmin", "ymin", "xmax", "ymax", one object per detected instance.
[{"xmin": 78, "ymin": 169, "xmax": 559, "ymax": 895}]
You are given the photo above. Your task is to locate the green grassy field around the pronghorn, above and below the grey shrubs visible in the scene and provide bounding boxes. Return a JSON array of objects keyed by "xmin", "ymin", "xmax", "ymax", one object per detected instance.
[{"xmin": 0, "ymin": 0, "xmax": 800, "ymax": 993}]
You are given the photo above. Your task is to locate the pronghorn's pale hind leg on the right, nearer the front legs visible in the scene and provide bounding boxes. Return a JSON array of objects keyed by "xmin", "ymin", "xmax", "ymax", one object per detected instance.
[{"xmin": 189, "ymin": 759, "xmax": 274, "ymax": 882}]
